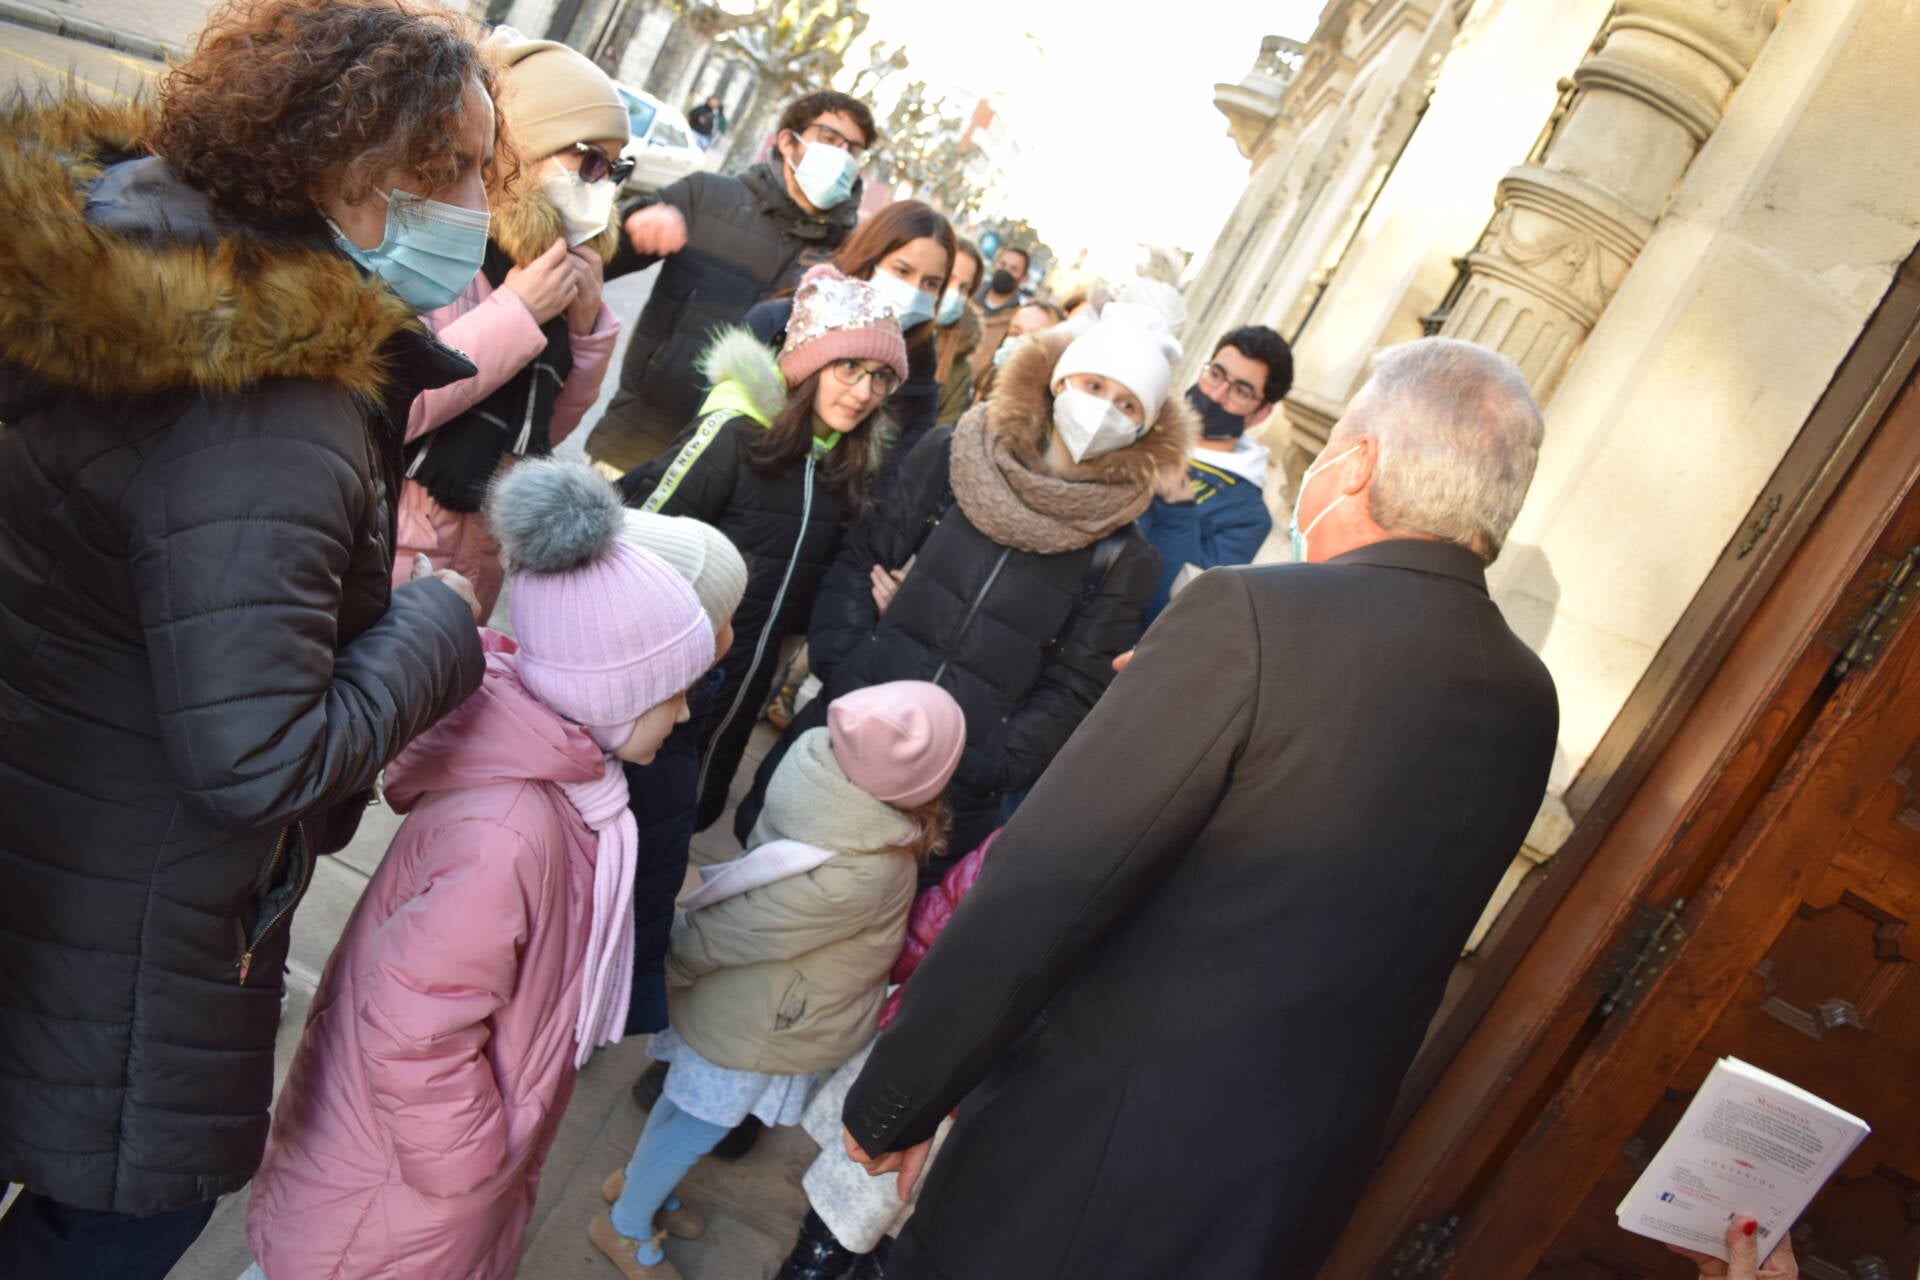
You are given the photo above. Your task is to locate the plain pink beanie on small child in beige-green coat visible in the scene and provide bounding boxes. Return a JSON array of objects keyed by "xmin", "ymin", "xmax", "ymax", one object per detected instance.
[{"xmin": 828, "ymin": 679, "xmax": 966, "ymax": 808}]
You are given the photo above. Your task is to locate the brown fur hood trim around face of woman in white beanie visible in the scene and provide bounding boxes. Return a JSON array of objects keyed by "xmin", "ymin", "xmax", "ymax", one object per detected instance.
[{"xmin": 985, "ymin": 330, "xmax": 1200, "ymax": 487}]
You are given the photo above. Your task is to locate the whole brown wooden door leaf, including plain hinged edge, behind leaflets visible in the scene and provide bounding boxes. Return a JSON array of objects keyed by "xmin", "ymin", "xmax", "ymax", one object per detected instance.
[{"xmin": 1446, "ymin": 529, "xmax": 1920, "ymax": 1280}]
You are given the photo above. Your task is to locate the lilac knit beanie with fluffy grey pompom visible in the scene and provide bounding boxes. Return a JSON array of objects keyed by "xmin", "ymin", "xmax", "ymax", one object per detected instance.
[{"xmin": 488, "ymin": 459, "xmax": 714, "ymax": 750}]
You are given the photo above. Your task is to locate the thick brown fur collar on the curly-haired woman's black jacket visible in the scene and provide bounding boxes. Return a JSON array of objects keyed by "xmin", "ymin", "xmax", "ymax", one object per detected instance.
[{"xmin": 0, "ymin": 92, "xmax": 420, "ymax": 397}]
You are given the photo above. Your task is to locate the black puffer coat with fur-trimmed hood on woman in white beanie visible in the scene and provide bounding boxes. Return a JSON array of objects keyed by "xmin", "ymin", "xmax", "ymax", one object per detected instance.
[{"xmin": 735, "ymin": 328, "xmax": 1190, "ymax": 852}]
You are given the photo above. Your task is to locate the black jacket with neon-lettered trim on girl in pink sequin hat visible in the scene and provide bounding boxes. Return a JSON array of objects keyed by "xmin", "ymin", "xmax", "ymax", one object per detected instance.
[{"xmin": 620, "ymin": 330, "xmax": 872, "ymax": 831}]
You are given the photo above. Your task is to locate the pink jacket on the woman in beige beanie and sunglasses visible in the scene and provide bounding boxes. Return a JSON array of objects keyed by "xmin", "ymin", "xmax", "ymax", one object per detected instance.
[{"xmin": 394, "ymin": 274, "xmax": 620, "ymax": 614}]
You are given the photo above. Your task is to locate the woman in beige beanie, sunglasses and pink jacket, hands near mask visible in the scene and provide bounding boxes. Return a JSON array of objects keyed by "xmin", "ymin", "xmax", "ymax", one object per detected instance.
[{"xmin": 394, "ymin": 29, "xmax": 634, "ymax": 614}]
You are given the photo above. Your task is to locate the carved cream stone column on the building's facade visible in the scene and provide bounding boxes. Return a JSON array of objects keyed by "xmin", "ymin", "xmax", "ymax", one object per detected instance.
[{"xmin": 1440, "ymin": 0, "xmax": 1786, "ymax": 403}]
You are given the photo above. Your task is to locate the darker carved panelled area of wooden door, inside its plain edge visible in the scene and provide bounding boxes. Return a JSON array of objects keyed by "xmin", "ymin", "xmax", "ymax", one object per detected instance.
[{"xmin": 1532, "ymin": 690, "xmax": 1920, "ymax": 1280}]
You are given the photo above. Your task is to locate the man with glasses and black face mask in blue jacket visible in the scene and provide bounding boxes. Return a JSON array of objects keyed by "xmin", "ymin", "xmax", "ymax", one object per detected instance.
[{"xmin": 1140, "ymin": 324, "xmax": 1294, "ymax": 624}]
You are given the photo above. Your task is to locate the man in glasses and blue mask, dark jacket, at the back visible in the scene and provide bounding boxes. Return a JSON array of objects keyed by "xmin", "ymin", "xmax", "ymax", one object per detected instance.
[{"xmin": 588, "ymin": 90, "xmax": 874, "ymax": 472}]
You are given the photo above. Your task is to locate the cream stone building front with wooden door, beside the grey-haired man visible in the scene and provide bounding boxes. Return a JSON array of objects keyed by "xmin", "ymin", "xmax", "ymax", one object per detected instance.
[{"xmin": 1188, "ymin": 0, "xmax": 1920, "ymax": 1280}]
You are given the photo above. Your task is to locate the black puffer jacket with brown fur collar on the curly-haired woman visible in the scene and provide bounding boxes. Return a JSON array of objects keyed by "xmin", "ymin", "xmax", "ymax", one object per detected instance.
[{"xmin": 0, "ymin": 102, "xmax": 482, "ymax": 1215}]
